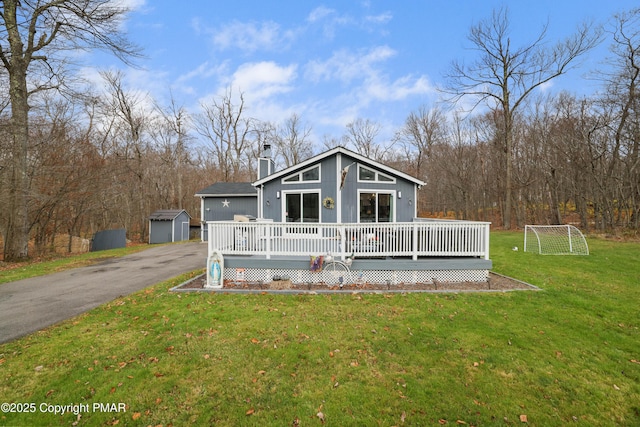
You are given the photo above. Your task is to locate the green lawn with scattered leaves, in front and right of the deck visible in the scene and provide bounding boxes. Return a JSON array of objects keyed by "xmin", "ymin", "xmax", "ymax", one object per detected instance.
[{"xmin": 0, "ymin": 232, "xmax": 640, "ymax": 426}]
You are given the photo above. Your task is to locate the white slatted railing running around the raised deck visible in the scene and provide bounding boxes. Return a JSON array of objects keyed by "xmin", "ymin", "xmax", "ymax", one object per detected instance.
[{"xmin": 207, "ymin": 219, "xmax": 490, "ymax": 259}]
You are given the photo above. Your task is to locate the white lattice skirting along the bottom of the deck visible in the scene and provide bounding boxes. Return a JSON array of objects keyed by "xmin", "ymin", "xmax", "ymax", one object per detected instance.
[{"xmin": 224, "ymin": 268, "xmax": 489, "ymax": 285}]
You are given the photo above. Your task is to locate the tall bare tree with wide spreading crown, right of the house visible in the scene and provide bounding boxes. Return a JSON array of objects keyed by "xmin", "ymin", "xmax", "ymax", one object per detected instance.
[{"xmin": 446, "ymin": 8, "xmax": 600, "ymax": 228}]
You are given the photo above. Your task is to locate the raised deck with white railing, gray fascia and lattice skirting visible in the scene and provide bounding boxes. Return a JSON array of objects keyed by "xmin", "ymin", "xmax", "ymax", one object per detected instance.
[{"xmin": 208, "ymin": 220, "xmax": 492, "ymax": 283}]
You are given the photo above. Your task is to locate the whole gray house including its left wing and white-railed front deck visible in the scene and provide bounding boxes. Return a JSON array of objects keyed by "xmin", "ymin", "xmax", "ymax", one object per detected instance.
[{"xmin": 202, "ymin": 147, "xmax": 491, "ymax": 286}]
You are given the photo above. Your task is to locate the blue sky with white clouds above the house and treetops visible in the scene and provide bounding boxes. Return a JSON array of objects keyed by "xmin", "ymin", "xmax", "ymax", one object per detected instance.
[{"xmin": 95, "ymin": 0, "xmax": 636, "ymax": 143}]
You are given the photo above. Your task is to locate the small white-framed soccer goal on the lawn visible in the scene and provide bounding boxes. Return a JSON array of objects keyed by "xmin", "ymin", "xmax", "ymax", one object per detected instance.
[{"xmin": 524, "ymin": 225, "xmax": 589, "ymax": 255}]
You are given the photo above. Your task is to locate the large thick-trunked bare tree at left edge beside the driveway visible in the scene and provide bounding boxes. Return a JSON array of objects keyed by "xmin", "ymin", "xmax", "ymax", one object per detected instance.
[{"xmin": 0, "ymin": 0, "xmax": 137, "ymax": 260}]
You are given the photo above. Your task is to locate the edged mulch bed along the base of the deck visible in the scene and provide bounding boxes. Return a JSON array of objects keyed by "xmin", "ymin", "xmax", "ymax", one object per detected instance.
[{"xmin": 172, "ymin": 272, "xmax": 539, "ymax": 292}]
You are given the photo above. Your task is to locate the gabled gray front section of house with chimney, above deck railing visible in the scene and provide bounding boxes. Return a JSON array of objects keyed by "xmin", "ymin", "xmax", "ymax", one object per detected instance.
[{"xmin": 253, "ymin": 147, "xmax": 424, "ymax": 224}]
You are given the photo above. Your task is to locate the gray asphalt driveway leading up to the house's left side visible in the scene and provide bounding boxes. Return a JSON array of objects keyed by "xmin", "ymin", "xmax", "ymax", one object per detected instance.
[{"xmin": 0, "ymin": 242, "xmax": 207, "ymax": 343}]
